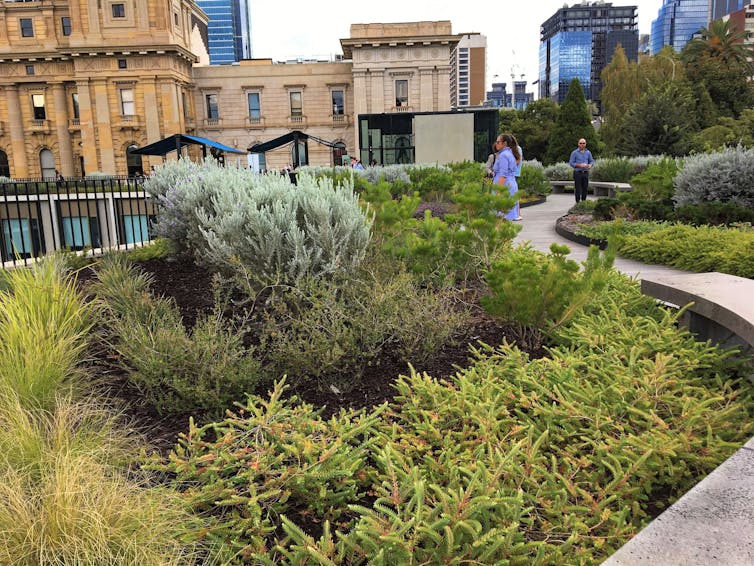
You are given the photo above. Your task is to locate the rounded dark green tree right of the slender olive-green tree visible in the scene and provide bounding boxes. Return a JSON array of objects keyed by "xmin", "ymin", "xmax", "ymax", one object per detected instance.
[{"xmin": 617, "ymin": 82, "xmax": 699, "ymax": 156}]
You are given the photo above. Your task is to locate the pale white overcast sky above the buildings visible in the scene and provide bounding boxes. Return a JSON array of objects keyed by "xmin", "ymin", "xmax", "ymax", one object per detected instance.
[{"xmin": 250, "ymin": 0, "xmax": 662, "ymax": 92}]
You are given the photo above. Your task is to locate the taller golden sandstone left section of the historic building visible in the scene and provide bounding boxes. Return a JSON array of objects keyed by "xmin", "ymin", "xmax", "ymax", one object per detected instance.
[{"xmin": 0, "ymin": 0, "xmax": 207, "ymax": 178}]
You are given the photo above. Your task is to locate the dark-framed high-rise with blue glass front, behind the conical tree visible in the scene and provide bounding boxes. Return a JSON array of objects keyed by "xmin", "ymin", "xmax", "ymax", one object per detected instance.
[{"xmin": 539, "ymin": 0, "xmax": 639, "ymax": 104}]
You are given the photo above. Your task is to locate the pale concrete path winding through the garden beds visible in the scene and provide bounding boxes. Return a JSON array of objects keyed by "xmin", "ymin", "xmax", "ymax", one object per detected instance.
[{"xmin": 515, "ymin": 194, "xmax": 688, "ymax": 279}]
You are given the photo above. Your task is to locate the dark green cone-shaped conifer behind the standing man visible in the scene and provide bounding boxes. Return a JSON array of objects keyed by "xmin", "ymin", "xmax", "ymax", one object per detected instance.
[{"xmin": 545, "ymin": 78, "xmax": 599, "ymax": 163}]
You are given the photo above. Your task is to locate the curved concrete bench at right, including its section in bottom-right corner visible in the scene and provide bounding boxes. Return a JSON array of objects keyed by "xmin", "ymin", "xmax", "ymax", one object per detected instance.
[{"xmin": 602, "ymin": 273, "xmax": 754, "ymax": 566}]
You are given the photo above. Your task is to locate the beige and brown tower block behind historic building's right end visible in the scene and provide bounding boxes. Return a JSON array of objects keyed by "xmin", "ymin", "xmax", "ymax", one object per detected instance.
[{"xmin": 450, "ymin": 33, "xmax": 487, "ymax": 108}]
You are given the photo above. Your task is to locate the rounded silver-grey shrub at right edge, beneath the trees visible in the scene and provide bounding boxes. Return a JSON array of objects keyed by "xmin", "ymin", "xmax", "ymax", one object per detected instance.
[{"xmin": 673, "ymin": 146, "xmax": 754, "ymax": 207}]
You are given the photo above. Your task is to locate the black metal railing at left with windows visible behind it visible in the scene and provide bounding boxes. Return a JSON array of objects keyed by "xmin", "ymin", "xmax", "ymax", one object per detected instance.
[{"xmin": 0, "ymin": 177, "xmax": 157, "ymax": 268}]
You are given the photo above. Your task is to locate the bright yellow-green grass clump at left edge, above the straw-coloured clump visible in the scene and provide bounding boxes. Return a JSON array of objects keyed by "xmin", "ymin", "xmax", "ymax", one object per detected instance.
[{"xmin": 0, "ymin": 255, "xmax": 91, "ymax": 410}]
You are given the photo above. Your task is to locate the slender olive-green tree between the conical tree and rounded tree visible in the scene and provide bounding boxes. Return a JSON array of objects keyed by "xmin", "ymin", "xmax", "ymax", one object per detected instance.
[{"xmin": 600, "ymin": 44, "xmax": 641, "ymax": 151}]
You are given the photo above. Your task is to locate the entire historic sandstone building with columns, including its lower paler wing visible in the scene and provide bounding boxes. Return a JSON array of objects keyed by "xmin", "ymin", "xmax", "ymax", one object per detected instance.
[{"xmin": 0, "ymin": 7, "xmax": 476, "ymax": 178}]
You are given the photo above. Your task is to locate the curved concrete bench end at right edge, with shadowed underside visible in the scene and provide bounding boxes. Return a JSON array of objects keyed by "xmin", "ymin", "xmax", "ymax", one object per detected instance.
[{"xmin": 641, "ymin": 272, "xmax": 754, "ymax": 347}]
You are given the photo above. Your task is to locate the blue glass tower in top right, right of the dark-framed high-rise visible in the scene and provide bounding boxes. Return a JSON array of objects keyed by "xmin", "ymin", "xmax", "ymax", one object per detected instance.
[{"xmin": 650, "ymin": 0, "xmax": 710, "ymax": 55}]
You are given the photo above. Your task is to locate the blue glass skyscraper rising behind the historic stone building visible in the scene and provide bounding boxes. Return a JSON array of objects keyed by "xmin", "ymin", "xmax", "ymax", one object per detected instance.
[{"xmin": 196, "ymin": 0, "xmax": 251, "ymax": 65}]
